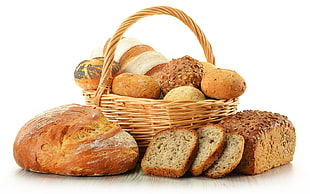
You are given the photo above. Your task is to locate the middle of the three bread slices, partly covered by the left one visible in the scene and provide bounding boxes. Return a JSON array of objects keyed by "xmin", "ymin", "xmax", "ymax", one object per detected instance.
[{"xmin": 190, "ymin": 124, "xmax": 226, "ymax": 176}]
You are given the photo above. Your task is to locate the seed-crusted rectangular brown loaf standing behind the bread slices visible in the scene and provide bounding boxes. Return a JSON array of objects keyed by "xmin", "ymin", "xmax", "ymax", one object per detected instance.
[{"xmin": 219, "ymin": 110, "xmax": 296, "ymax": 175}]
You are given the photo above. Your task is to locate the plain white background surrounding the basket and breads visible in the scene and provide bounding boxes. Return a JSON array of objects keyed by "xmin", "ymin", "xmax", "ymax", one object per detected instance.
[{"xmin": 0, "ymin": 0, "xmax": 310, "ymax": 193}]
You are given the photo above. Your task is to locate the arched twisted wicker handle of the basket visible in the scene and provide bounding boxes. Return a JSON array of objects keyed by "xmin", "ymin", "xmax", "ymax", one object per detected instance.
[{"xmin": 93, "ymin": 6, "xmax": 215, "ymax": 106}]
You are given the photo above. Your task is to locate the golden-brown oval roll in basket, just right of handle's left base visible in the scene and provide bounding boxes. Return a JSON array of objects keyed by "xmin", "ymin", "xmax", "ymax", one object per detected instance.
[{"xmin": 112, "ymin": 73, "xmax": 161, "ymax": 99}]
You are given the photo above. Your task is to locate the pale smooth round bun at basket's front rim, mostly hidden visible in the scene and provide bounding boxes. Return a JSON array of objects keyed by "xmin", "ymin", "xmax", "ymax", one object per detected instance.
[{"xmin": 164, "ymin": 86, "xmax": 206, "ymax": 101}]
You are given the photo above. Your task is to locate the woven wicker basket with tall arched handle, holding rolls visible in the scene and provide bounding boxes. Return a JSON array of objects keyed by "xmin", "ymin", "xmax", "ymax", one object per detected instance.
[{"xmin": 83, "ymin": 6, "xmax": 238, "ymax": 150}]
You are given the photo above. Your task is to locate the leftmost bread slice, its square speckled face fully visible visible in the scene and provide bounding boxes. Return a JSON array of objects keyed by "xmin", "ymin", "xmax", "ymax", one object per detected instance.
[{"xmin": 141, "ymin": 129, "xmax": 198, "ymax": 177}]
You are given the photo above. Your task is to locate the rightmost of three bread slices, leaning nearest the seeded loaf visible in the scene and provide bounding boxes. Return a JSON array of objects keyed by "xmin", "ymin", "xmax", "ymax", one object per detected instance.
[{"xmin": 205, "ymin": 134, "xmax": 244, "ymax": 178}]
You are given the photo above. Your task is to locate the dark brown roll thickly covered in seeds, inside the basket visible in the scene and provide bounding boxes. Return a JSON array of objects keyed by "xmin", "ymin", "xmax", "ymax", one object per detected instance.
[{"xmin": 160, "ymin": 56, "xmax": 203, "ymax": 95}]
